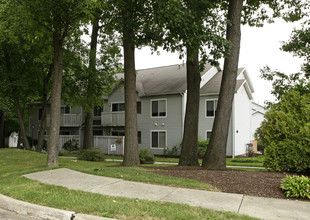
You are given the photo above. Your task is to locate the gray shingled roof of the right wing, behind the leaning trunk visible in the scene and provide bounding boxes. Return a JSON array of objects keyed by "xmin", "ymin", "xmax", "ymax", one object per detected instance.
[{"xmin": 200, "ymin": 68, "xmax": 245, "ymax": 94}]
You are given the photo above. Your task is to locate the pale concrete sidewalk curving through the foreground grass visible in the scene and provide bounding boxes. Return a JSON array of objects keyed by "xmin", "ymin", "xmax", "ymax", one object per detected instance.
[{"xmin": 24, "ymin": 168, "xmax": 310, "ymax": 220}]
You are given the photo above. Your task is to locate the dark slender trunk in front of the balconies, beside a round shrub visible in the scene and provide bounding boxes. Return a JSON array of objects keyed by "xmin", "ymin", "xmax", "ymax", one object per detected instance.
[{"xmin": 83, "ymin": 16, "xmax": 99, "ymax": 149}]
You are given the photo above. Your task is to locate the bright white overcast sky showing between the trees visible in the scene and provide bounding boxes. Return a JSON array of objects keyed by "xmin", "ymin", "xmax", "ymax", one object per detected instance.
[{"xmin": 136, "ymin": 20, "xmax": 302, "ymax": 104}]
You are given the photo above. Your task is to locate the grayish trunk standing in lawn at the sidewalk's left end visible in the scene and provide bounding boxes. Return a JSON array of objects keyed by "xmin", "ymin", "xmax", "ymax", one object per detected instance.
[{"xmin": 47, "ymin": 31, "xmax": 63, "ymax": 167}]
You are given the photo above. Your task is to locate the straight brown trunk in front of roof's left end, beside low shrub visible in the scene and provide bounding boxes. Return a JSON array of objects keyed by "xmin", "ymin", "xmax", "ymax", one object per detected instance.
[{"xmin": 123, "ymin": 38, "xmax": 140, "ymax": 166}]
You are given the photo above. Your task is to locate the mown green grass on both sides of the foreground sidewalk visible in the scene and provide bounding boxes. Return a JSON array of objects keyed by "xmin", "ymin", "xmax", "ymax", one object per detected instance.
[{"xmin": 0, "ymin": 149, "xmax": 254, "ymax": 219}]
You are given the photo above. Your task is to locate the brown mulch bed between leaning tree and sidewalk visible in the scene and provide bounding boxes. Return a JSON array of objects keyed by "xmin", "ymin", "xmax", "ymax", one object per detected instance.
[{"xmin": 145, "ymin": 166, "xmax": 306, "ymax": 199}]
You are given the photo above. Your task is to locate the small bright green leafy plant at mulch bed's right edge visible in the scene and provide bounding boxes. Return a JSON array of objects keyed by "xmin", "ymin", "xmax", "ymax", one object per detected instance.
[{"xmin": 280, "ymin": 176, "xmax": 310, "ymax": 199}]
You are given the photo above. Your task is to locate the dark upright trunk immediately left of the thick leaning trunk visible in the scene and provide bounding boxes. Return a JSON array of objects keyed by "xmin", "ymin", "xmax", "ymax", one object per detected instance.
[{"xmin": 179, "ymin": 48, "xmax": 201, "ymax": 166}]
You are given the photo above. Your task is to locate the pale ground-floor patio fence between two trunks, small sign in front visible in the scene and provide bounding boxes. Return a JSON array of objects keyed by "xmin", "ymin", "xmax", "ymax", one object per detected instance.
[{"xmin": 94, "ymin": 136, "xmax": 125, "ymax": 155}]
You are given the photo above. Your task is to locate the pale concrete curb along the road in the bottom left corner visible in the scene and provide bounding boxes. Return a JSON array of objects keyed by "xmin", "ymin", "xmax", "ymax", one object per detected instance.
[{"xmin": 0, "ymin": 194, "xmax": 114, "ymax": 220}]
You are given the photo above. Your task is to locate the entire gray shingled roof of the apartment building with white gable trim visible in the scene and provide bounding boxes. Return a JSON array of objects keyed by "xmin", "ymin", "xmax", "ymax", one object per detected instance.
[{"xmin": 116, "ymin": 63, "xmax": 254, "ymax": 99}]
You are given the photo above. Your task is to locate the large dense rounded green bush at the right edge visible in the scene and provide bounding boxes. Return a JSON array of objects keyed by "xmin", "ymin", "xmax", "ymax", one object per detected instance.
[{"xmin": 256, "ymin": 90, "xmax": 310, "ymax": 173}]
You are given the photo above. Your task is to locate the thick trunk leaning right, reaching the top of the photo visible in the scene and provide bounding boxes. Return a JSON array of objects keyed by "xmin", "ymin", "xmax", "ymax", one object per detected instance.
[{"xmin": 202, "ymin": 0, "xmax": 243, "ymax": 170}]
